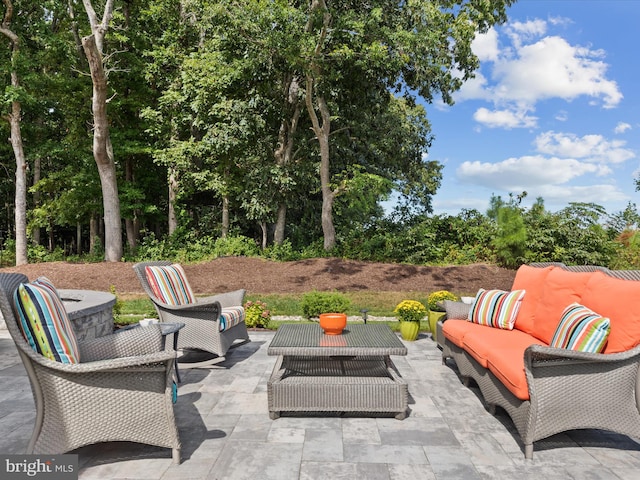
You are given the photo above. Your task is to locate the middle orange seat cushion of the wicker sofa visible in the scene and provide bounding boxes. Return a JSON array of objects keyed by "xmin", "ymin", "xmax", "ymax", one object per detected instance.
[{"xmin": 462, "ymin": 325, "xmax": 542, "ymax": 371}]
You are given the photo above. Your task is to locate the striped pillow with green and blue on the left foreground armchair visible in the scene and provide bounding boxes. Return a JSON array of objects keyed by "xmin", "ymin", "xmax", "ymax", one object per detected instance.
[{"xmin": 14, "ymin": 277, "xmax": 80, "ymax": 363}]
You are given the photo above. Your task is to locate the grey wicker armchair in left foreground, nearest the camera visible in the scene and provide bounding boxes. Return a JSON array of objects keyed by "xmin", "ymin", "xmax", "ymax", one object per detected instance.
[{"xmin": 0, "ymin": 273, "xmax": 181, "ymax": 463}]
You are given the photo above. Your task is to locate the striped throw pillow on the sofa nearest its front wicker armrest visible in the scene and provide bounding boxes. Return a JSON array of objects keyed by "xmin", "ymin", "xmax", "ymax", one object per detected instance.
[{"xmin": 550, "ymin": 303, "xmax": 611, "ymax": 353}]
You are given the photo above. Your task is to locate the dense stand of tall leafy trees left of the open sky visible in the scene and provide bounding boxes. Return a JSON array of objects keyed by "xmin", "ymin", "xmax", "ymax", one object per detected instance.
[{"xmin": 0, "ymin": 0, "xmax": 513, "ymax": 263}]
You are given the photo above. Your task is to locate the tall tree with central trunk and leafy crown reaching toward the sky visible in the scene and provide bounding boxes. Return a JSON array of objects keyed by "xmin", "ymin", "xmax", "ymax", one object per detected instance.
[{"xmin": 301, "ymin": 0, "xmax": 513, "ymax": 250}]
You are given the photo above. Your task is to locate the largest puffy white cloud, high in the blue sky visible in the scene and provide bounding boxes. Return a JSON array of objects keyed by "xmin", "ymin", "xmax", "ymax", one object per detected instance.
[{"xmin": 455, "ymin": 18, "xmax": 623, "ymax": 128}]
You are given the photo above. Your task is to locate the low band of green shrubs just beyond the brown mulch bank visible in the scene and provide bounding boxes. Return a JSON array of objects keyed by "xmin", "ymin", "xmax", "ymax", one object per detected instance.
[{"xmin": 0, "ymin": 196, "xmax": 640, "ymax": 269}]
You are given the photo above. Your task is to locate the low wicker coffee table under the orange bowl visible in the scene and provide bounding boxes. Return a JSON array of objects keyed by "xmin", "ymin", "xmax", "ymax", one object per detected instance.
[{"xmin": 267, "ymin": 324, "xmax": 408, "ymax": 420}]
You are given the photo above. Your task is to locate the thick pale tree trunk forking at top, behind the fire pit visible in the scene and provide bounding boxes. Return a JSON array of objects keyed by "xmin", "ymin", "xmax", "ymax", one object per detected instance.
[{"xmin": 82, "ymin": 0, "xmax": 123, "ymax": 262}]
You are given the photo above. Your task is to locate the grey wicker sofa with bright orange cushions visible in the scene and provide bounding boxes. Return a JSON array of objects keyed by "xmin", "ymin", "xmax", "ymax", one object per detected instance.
[{"xmin": 439, "ymin": 264, "xmax": 640, "ymax": 459}]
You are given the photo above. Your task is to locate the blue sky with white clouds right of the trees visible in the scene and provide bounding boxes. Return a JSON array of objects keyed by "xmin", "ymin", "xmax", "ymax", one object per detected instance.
[{"xmin": 426, "ymin": 0, "xmax": 640, "ymax": 215}]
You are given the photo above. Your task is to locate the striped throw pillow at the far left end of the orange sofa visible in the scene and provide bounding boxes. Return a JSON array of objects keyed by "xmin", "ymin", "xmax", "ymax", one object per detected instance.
[{"xmin": 469, "ymin": 288, "xmax": 525, "ymax": 330}]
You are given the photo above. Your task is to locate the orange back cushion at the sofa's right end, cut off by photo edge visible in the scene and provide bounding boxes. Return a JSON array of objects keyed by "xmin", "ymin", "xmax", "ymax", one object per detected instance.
[{"xmin": 582, "ymin": 272, "xmax": 640, "ymax": 353}]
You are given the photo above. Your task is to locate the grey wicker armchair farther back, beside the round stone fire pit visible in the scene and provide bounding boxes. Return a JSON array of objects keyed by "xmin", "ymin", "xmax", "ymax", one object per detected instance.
[{"xmin": 133, "ymin": 261, "xmax": 249, "ymax": 368}]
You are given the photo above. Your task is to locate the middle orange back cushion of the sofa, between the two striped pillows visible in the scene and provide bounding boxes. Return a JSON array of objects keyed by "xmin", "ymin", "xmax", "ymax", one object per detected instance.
[{"xmin": 525, "ymin": 268, "xmax": 592, "ymax": 345}]
